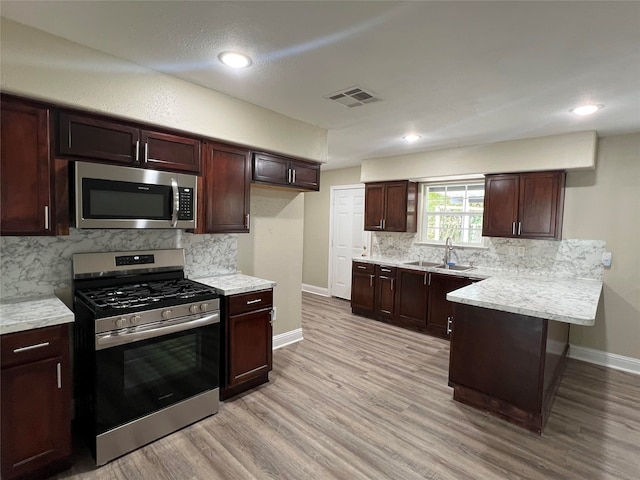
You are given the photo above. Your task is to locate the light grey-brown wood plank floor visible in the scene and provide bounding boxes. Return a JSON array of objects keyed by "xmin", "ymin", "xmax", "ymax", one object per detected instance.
[{"xmin": 56, "ymin": 294, "xmax": 640, "ymax": 480}]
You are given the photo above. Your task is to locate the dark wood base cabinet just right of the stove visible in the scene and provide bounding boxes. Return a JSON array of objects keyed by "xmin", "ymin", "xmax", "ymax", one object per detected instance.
[{"xmin": 220, "ymin": 289, "xmax": 273, "ymax": 400}]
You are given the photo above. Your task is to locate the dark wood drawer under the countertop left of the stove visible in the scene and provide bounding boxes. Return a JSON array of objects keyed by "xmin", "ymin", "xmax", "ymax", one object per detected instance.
[{"xmin": 0, "ymin": 324, "xmax": 68, "ymax": 368}]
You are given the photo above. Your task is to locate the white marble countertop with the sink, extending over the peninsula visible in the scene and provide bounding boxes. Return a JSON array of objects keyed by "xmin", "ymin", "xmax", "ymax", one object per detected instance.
[{"xmin": 353, "ymin": 257, "xmax": 602, "ymax": 326}]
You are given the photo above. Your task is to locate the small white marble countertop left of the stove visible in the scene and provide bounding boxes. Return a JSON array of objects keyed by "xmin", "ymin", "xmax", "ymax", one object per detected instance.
[{"xmin": 0, "ymin": 296, "xmax": 74, "ymax": 334}]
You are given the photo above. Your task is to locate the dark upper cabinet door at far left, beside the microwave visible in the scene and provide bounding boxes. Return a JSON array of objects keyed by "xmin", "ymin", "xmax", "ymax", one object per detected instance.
[{"xmin": 0, "ymin": 99, "xmax": 53, "ymax": 235}]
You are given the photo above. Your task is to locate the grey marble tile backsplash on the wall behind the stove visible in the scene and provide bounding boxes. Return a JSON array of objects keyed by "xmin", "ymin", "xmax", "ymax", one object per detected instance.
[{"xmin": 0, "ymin": 228, "xmax": 238, "ymax": 300}]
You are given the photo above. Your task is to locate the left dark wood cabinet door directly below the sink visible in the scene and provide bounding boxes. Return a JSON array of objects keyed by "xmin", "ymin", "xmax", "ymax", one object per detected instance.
[{"xmin": 395, "ymin": 269, "xmax": 430, "ymax": 330}]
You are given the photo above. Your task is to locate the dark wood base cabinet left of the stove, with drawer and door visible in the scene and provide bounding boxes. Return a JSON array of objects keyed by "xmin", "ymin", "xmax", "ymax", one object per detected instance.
[{"xmin": 0, "ymin": 324, "xmax": 71, "ymax": 480}]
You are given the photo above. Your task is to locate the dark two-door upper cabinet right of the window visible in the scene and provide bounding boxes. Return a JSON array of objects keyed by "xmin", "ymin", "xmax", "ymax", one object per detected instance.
[{"xmin": 482, "ymin": 171, "xmax": 565, "ymax": 240}]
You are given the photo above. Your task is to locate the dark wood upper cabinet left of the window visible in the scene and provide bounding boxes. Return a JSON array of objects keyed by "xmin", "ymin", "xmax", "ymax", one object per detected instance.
[{"xmin": 364, "ymin": 180, "xmax": 418, "ymax": 233}]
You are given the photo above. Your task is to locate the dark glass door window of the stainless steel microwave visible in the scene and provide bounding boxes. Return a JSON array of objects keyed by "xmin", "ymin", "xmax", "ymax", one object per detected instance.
[{"xmin": 82, "ymin": 178, "xmax": 173, "ymax": 220}]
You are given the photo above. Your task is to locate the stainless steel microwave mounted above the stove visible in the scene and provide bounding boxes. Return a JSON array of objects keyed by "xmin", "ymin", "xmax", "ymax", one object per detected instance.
[{"xmin": 75, "ymin": 162, "xmax": 197, "ymax": 229}]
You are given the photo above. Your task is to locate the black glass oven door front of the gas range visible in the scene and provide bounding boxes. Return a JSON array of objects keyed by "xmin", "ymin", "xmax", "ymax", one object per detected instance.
[{"xmin": 96, "ymin": 324, "xmax": 219, "ymax": 434}]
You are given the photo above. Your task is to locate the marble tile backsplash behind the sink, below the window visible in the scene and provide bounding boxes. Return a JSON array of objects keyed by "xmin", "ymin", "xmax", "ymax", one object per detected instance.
[{"xmin": 371, "ymin": 233, "xmax": 606, "ymax": 280}]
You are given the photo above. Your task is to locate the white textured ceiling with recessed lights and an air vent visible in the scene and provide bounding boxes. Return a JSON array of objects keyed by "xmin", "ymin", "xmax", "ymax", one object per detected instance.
[{"xmin": 0, "ymin": 0, "xmax": 640, "ymax": 168}]
